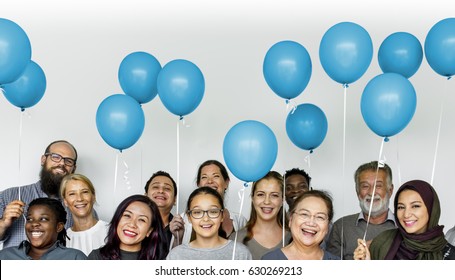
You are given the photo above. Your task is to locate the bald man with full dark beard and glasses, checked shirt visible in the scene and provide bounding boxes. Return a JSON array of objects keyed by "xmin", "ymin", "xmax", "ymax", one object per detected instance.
[{"xmin": 0, "ymin": 140, "xmax": 77, "ymax": 248}]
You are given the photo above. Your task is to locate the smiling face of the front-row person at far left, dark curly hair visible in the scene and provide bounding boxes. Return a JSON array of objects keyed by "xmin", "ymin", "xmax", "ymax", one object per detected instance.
[{"xmin": 25, "ymin": 205, "xmax": 65, "ymax": 251}]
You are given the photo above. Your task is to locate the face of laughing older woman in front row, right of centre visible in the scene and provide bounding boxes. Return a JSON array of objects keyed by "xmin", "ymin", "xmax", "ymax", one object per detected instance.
[{"xmin": 289, "ymin": 196, "xmax": 329, "ymax": 247}]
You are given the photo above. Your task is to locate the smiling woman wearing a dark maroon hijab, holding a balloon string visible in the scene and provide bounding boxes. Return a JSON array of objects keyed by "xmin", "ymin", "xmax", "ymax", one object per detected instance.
[{"xmin": 354, "ymin": 180, "xmax": 455, "ymax": 260}]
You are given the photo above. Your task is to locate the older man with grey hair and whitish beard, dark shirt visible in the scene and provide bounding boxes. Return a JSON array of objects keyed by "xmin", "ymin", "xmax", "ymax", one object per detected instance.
[{"xmin": 327, "ymin": 161, "xmax": 396, "ymax": 260}]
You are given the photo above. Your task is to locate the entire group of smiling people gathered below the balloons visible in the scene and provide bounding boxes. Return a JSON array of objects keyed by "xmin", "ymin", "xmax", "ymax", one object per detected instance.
[{"xmin": 0, "ymin": 140, "xmax": 455, "ymax": 260}]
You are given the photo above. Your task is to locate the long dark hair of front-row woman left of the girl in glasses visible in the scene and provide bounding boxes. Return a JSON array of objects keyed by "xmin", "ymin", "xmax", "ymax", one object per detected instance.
[{"xmin": 100, "ymin": 194, "xmax": 169, "ymax": 260}]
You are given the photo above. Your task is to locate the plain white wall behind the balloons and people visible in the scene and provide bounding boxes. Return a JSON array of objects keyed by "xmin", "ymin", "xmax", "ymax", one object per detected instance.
[{"xmin": 0, "ymin": 0, "xmax": 455, "ymax": 231}]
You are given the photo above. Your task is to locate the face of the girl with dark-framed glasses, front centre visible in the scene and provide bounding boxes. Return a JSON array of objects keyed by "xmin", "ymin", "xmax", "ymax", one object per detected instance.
[{"xmin": 188, "ymin": 194, "xmax": 223, "ymax": 239}]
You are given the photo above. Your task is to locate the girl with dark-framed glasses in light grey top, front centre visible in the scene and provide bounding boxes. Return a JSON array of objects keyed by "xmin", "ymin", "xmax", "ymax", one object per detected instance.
[{"xmin": 167, "ymin": 187, "xmax": 252, "ymax": 260}]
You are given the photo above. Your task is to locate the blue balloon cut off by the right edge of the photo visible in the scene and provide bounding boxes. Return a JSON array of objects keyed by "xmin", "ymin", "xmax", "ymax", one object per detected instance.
[{"xmin": 425, "ymin": 18, "xmax": 455, "ymax": 77}]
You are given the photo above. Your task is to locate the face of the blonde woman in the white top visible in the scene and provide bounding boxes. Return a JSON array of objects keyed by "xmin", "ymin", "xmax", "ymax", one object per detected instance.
[{"xmin": 63, "ymin": 180, "xmax": 96, "ymax": 221}]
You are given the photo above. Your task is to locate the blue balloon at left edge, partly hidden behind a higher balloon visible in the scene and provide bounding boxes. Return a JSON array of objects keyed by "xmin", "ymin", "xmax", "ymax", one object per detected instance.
[{"xmin": 2, "ymin": 61, "xmax": 46, "ymax": 111}]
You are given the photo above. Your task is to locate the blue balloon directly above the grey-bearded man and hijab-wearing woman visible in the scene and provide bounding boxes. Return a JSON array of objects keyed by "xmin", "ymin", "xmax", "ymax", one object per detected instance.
[{"xmin": 360, "ymin": 73, "xmax": 417, "ymax": 137}]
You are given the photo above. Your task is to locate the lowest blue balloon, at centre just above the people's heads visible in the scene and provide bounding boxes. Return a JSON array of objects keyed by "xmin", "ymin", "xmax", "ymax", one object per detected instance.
[{"xmin": 223, "ymin": 120, "xmax": 278, "ymax": 182}]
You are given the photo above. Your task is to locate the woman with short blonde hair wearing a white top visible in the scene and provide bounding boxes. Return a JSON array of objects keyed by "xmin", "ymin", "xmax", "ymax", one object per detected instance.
[{"xmin": 60, "ymin": 174, "xmax": 109, "ymax": 255}]
